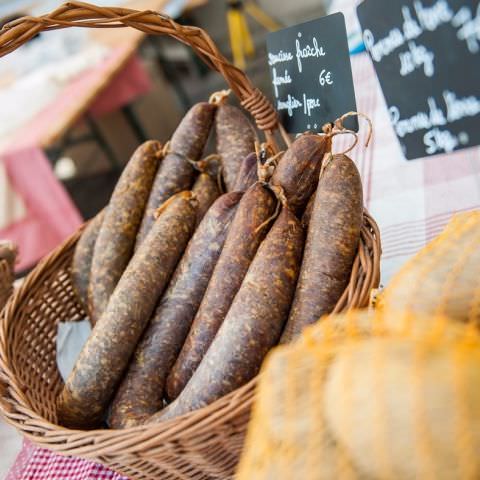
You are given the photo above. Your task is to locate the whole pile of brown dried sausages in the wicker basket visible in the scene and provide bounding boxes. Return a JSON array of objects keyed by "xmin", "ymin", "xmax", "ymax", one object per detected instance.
[{"xmin": 62, "ymin": 97, "xmax": 363, "ymax": 429}]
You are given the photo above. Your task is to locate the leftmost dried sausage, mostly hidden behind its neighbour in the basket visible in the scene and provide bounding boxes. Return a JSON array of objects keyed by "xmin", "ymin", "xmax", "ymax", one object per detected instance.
[{"xmin": 71, "ymin": 210, "xmax": 105, "ymax": 313}]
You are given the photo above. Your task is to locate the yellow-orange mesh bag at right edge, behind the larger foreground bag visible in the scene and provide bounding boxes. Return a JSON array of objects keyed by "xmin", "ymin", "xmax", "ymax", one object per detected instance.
[{"xmin": 382, "ymin": 210, "xmax": 480, "ymax": 326}]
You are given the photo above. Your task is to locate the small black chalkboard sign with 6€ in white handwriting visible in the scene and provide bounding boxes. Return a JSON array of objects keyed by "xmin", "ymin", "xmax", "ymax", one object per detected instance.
[{"xmin": 267, "ymin": 13, "xmax": 358, "ymax": 133}]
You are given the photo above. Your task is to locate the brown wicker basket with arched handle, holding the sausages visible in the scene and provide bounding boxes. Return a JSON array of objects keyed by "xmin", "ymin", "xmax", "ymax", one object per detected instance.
[{"xmin": 0, "ymin": 2, "xmax": 380, "ymax": 480}]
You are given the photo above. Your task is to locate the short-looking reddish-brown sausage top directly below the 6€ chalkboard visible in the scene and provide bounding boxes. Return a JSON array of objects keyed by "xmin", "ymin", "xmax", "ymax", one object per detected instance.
[{"xmin": 270, "ymin": 134, "xmax": 332, "ymax": 214}]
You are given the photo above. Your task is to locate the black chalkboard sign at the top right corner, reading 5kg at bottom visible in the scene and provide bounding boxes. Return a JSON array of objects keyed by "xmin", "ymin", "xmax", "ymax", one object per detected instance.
[{"xmin": 357, "ymin": 0, "xmax": 480, "ymax": 160}]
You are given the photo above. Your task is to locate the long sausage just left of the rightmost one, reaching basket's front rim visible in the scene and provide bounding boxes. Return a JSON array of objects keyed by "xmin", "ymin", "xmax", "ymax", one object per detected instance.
[{"xmin": 149, "ymin": 208, "xmax": 304, "ymax": 422}]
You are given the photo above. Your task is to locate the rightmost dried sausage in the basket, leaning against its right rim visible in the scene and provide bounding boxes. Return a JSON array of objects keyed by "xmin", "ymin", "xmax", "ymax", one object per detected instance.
[{"xmin": 281, "ymin": 154, "xmax": 363, "ymax": 343}]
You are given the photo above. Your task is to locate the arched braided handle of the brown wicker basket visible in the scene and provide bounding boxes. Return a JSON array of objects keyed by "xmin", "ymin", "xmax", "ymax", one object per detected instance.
[{"xmin": 0, "ymin": 1, "xmax": 289, "ymax": 150}]
